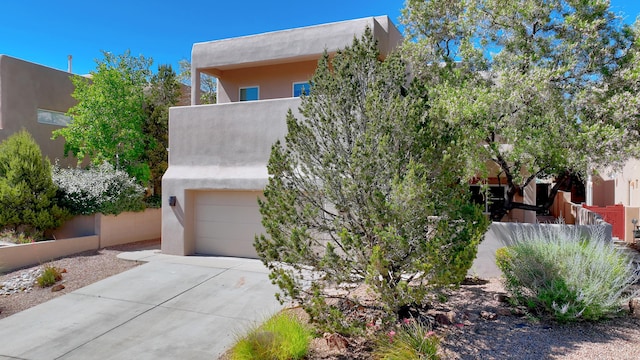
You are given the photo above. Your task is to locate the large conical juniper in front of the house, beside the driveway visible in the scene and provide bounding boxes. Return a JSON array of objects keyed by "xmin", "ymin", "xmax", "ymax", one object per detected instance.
[{"xmin": 255, "ymin": 30, "xmax": 487, "ymax": 331}]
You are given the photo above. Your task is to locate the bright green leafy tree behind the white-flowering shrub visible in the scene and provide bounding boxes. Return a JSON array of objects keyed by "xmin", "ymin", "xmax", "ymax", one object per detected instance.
[{"xmin": 53, "ymin": 51, "xmax": 152, "ymax": 183}]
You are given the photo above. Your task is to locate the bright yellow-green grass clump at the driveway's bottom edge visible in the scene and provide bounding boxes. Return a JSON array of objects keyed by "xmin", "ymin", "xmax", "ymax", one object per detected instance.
[{"xmin": 231, "ymin": 313, "xmax": 313, "ymax": 360}]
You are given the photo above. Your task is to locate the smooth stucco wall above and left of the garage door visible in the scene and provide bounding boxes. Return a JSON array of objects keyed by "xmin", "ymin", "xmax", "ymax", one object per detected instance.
[{"xmin": 162, "ymin": 98, "xmax": 300, "ymax": 255}]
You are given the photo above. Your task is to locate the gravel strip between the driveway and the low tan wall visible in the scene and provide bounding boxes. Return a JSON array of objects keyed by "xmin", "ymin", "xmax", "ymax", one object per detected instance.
[{"xmin": 0, "ymin": 240, "xmax": 160, "ymax": 319}]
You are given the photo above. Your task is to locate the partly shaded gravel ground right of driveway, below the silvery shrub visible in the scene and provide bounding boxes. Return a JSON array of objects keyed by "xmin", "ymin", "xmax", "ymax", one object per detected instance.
[{"xmin": 308, "ymin": 279, "xmax": 640, "ymax": 360}]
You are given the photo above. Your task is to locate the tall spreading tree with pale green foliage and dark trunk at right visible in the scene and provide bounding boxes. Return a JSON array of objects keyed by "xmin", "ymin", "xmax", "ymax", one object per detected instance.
[{"xmin": 403, "ymin": 0, "xmax": 637, "ymax": 219}]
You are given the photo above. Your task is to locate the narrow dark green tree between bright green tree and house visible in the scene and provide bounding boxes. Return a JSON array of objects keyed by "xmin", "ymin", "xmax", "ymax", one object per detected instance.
[{"xmin": 142, "ymin": 65, "xmax": 180, "ymax": 195}]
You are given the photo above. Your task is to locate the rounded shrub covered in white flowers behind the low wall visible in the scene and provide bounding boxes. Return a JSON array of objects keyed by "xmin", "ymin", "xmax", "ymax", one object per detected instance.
[{"xmin": 52, "ymin": 162, "xmax": 145, "ymax": 215}]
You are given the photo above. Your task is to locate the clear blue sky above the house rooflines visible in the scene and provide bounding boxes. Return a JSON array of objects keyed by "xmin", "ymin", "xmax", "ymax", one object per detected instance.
[{"xmin": 0, "ymin": 0, "xmax": 640, "ymax": 74}]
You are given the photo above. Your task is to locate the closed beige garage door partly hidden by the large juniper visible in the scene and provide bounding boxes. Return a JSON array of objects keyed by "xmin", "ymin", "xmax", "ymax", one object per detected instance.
[{"xmin": 195, "ymin": 191, "xmax": 264, "ymax": 258}]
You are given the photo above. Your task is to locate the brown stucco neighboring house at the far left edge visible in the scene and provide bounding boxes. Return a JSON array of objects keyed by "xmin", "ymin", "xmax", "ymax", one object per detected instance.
[{"xmin": 0, "ymin": 55, "xmax": 77, "ymax": 166}]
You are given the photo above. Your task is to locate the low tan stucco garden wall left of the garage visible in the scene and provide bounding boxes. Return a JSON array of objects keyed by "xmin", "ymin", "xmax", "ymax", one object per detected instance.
[{"xmin": 0, "ymin": 209, "xmax": 162, "ymax": 272}]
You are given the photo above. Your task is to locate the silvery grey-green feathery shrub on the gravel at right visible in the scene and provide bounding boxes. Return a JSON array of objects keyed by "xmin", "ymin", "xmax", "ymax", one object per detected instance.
[{"xmin": 496, "ymin": 225, "xmax": 640, "ymax": 322}]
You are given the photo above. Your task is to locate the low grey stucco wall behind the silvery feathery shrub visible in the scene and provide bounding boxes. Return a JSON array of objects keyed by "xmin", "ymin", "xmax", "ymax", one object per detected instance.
[{"xmin": 469, "ymin": 222, "xmax": 611, "ymax": 279}]
